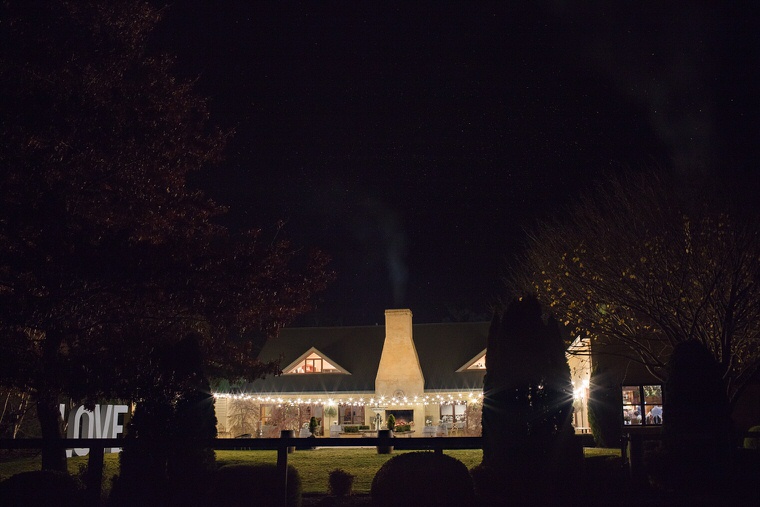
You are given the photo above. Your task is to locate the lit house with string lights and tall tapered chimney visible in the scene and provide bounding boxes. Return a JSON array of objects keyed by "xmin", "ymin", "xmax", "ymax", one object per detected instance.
[{"xmin": 215, "ymin": 309, "xmax": 591, "ymax": 437}]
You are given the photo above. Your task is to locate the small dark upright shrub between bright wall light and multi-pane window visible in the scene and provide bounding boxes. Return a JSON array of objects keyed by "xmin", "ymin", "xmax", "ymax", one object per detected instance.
[{"xmin": 588, "ymin": 364, "xmax": 621, "ymax": 447}]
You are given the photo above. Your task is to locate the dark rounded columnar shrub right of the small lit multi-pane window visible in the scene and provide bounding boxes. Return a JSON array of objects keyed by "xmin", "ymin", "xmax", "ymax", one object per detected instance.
[{"xmin": 659, "ymin": 340, "xmax": 732, "ymax": 495}]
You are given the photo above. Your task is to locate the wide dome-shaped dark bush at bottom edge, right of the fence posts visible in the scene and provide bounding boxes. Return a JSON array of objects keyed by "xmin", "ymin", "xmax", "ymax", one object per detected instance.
[{"xmin": 370, "ymin": 452, "xmax": 475, "ymax": 507}]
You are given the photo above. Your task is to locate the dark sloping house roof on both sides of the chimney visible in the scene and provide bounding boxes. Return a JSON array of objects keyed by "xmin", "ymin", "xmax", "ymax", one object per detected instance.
[{"xmin": 244, "ymin": 322, "xmax": 489, "ymax": 395}]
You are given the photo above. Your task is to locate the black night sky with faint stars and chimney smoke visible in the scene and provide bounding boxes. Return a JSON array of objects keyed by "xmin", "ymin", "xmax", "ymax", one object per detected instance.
[{"xmin": 150, "ymin": 0, "xmax": 760, "ymax": 325}]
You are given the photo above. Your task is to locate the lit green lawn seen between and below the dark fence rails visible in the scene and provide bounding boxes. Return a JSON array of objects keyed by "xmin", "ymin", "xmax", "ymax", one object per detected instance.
[{"xmin": 0, "ymin": 447, "xmax": 620, "ymax": 496}]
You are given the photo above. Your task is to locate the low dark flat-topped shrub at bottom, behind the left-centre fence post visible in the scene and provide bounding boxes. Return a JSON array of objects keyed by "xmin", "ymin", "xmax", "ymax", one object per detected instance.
[{"xmin": 211, "ymin": 463, "xmax": 302, "ymax": 507}]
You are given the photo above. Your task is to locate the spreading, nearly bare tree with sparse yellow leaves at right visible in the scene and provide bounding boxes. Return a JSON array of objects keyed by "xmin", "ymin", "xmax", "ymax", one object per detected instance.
[{"xmin": 506, "ymin": 174, "xmax": 760, "ymax": 404}]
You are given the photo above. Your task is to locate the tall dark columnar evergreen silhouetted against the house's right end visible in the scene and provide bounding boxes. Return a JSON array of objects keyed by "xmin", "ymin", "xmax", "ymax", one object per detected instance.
[{"xmin": 483, "ymin": 298, "xmax": 583, "ymax": 503}]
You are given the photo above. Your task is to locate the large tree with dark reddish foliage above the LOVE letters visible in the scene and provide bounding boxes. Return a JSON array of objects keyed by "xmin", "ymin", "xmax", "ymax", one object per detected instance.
[{"xmin": 0, "ymin": 0, "xmax": 330, "ymax": 470}]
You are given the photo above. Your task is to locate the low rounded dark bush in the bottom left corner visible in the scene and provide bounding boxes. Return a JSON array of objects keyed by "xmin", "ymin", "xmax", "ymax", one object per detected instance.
[{"xmin": 0, "ymin": 470, "xmax": 82, "ymax": 507}]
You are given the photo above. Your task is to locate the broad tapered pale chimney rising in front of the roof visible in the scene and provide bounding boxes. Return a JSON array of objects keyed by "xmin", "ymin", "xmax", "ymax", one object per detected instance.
[{"xmin": 375, "ymin": 309, "xmax": 425, "ymax": 397}]
